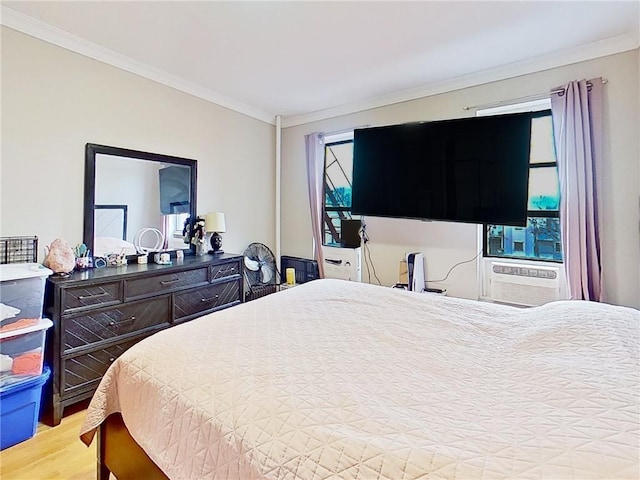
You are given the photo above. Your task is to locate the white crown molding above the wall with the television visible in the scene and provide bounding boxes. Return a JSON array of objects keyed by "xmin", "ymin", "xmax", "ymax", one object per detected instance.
[{"xmin": 282, "ymin": 31, "xmax": 640, "ymax": 128}]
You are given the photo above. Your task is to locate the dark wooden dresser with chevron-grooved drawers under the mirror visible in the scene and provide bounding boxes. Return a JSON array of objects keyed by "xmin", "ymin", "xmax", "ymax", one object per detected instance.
[{"xmin": 45, "ymin": 254, "xmax": 244, "ymax": 425}]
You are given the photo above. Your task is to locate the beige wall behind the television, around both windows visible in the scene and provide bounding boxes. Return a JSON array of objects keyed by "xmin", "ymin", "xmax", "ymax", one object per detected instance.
[{"xmin": 282, "ymin": 50, "xmax": 640, "ymax": 307}]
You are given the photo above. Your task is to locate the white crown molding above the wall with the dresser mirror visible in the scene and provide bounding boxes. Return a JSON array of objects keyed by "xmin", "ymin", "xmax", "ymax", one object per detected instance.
[{"xmin": 0, "ymin": 5, "xmax": 275, "ymax": 125}]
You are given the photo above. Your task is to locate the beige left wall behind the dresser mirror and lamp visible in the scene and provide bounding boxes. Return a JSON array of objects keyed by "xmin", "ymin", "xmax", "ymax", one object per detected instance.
[{"xmin": 0, "ymin": 27, "xmax": 275, "ymax": 260}]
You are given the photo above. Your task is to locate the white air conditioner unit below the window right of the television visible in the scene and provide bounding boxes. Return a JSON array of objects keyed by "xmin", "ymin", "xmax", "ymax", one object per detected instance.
[{"xmin": 489, "ymin": 262, "xmax": 560, "ymax": 307}]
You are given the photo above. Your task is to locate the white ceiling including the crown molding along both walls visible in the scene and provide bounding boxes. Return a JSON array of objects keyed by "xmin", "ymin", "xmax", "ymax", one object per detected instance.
[{"xmin": 1, "ymin": 1, "xmax": 640, "ymax": 126}]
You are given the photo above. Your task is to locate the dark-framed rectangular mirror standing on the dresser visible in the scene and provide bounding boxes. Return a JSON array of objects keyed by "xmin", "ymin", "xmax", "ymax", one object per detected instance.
[{"xmin": 84, "ymin": 143, "xmax": 197, "ymax": 257}]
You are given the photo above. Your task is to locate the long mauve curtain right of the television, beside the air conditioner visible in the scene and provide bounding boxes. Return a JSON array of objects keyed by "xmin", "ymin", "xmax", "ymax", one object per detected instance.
[{"xmin": 551, "ymin": 78, "xmax": 603, "ymax": 301}]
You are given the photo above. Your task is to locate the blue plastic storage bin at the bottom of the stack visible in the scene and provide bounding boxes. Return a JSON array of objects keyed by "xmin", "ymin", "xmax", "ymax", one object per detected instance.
[{"xmin": 0, "ymin": 366, "xmax": 51, "ymax": 450}]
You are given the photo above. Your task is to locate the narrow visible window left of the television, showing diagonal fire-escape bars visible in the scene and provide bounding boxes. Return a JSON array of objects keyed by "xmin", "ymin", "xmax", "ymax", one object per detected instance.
[{"xmin": 323, "ymin": 132, "xmax": 354, "ymax": 245}]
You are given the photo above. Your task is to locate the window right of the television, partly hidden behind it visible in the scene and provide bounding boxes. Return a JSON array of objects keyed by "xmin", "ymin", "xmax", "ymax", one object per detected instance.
[{"xmin": 483, "ymin": 106, "xmax": 562, "ymax": 262}]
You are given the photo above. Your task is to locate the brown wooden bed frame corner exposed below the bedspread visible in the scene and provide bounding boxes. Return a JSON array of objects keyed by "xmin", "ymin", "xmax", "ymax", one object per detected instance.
[{"xmin": 97, "ymin": 413, "xmax": 169, "ymax": 480}]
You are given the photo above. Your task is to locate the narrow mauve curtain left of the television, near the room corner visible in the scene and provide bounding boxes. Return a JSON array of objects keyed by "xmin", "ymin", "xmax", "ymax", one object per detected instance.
[{"xmin": 305, "ymin": 132, "xmax": 324, "ymax": 278}]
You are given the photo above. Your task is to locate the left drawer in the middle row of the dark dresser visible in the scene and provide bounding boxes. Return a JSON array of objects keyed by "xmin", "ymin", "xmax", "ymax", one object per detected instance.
[{"xmin": 62, "ymin": 295, "xmax": 171, "ymax": 354}]
